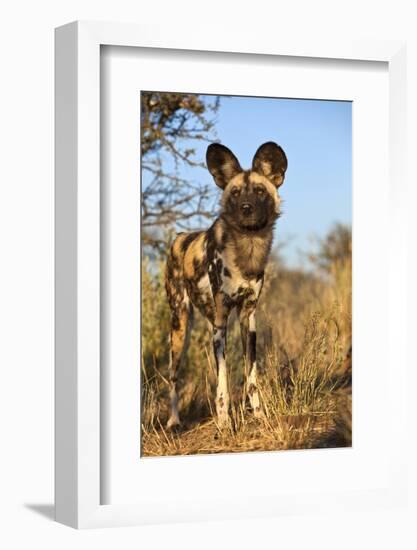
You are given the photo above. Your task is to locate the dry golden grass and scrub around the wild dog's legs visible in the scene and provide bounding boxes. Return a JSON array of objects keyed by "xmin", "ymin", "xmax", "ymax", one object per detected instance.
[{"xmin": 141, "ymin": 231, "xmax": 352, "ymax": 456}]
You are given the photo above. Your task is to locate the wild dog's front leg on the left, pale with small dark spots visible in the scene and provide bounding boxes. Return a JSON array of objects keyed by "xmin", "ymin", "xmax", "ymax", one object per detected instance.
[{"xmin": 213, "ymin": 327, "xmax": 230, "ymax": 428}]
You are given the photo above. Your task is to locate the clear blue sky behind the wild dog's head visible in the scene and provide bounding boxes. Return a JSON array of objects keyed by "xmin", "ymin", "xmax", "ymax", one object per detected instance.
[{"xmin": 145, "ymin": 96, "xmax": 352, "ymax": 266}]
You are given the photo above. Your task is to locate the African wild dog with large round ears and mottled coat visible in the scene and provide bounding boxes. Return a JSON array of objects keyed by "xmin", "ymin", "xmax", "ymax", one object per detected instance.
[{"xmin": 165, "ymin": 142, "xmax": 287, "ymax": 428}]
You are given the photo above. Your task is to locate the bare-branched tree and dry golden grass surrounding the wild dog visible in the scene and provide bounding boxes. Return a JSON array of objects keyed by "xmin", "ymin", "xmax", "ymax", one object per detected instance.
[{"xmin": 141, "ymin": 92, "xmax": 352, "ymax": 456}]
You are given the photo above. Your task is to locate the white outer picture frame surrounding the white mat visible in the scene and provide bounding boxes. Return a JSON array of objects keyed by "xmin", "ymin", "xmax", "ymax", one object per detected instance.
[{"xmin": 55, "ymin": 22, "xmax": 406, "ymax": 528}]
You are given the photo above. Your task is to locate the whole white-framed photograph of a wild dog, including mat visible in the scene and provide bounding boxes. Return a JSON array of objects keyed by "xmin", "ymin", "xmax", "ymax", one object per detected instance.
[{"xmin": 56, "ymin": 22, "xmax": 406, "ymax": 527}]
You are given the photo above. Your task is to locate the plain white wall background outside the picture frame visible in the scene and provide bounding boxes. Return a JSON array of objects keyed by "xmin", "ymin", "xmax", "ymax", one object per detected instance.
[{"xmin": 0, "ymin": 0, "xmax": 417, "ymax": 550}]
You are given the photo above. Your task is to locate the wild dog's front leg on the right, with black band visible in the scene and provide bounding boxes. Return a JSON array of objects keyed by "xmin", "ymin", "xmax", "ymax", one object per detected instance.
[{"xmin": 239, "ymin": 307, "xmax": 262, "ymax": 418}]
